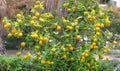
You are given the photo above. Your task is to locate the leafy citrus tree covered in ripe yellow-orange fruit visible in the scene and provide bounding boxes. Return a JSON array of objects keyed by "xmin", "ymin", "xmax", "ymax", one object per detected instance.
[{"xmin": 3, "ymin": 0, "xmax": 117, "ymax": 71}]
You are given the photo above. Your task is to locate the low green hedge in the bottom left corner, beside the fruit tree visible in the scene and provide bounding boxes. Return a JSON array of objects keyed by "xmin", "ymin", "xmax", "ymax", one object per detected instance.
[{"xmin": 0, "ymin": 56, "xmax": 32, "ymax": 71}]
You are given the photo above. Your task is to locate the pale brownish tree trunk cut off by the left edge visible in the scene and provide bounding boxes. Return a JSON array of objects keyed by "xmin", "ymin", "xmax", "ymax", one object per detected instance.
[{"xmin": 0, "ymin": 0, "xmax": 7, "ymax": 55}]
